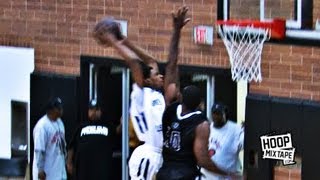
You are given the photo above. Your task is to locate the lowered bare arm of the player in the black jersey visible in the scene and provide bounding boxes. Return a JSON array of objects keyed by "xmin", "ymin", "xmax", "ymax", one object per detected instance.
[{"xmin": 193, "ymin": 121, "xmax": 226, "ymax": 175}]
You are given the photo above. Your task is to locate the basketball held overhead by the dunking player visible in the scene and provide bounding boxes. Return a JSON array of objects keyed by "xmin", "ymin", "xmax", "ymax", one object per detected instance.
[{"xmin": 93, "ymin": 18, "xmax": 123, "ymax": 46}]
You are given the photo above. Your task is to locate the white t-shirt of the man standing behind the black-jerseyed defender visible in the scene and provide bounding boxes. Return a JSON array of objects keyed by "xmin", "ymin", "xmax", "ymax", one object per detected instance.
[{"xmin": 204, "ymin": 121, "xmax": 244, "ymax": 179}]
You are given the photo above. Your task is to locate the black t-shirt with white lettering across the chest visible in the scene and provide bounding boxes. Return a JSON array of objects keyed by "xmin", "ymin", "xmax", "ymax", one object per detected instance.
[{"xmin": 69, "ymin": 121, "xmax": 116, "ymax": 180}]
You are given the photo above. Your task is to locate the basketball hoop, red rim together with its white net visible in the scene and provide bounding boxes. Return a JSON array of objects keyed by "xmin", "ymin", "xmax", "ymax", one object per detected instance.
[{"xmin": 217, "ymin": 19, "xmax": 285, "ymax": 82}]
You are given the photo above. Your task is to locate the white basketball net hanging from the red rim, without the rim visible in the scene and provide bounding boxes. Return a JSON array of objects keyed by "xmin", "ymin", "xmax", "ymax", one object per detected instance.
[{"xmin": 218, "ymin": 25, "xmax": 270, "ymax": 82}]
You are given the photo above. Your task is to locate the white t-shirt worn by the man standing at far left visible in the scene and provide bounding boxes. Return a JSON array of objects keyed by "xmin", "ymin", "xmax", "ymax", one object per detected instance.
[{"xmin": 32, "ymin": 115, "xmax": 67, "ymax": 180}]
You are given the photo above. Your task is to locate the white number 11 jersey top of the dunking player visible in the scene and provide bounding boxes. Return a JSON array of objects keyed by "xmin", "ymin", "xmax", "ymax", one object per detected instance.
[{"xmin": 130, "ymin": 84, "xmax": 166, "ymax": 149}]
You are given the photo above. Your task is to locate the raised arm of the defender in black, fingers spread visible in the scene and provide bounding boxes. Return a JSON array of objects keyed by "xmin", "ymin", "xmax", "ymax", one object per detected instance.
[{"xmin": 164, "ymin": 6, "xmax": 190, "ymax": 105}]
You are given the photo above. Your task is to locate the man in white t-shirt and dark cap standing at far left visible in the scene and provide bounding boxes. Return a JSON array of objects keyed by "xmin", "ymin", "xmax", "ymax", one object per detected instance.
[{"xmin": 32, "ymin": 98, "xmax": 67, "ymax": 180}]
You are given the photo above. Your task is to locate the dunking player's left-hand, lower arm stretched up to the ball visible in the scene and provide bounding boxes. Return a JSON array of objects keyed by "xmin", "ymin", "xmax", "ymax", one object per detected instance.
[{"xmin": 93, "ymin": 24, "xmax": 143, "ymax": 87}]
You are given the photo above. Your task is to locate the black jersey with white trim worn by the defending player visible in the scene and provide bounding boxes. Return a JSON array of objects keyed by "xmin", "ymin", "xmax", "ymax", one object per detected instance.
[{"xmin": 162, "ymin": 103, "xmax": 207, "ymax": 168}]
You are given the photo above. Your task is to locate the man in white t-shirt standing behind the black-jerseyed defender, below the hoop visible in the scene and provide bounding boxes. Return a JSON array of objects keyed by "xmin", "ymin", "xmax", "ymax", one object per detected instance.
[{"xmin": 202, "ymin": 104, "xmax": 244, "ymax": 180}]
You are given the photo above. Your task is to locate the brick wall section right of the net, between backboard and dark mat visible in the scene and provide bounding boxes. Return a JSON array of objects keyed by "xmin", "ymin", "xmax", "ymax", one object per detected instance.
[{"xmin": 250, "ymin": 44, "xmax": 320, "ymax": 100}]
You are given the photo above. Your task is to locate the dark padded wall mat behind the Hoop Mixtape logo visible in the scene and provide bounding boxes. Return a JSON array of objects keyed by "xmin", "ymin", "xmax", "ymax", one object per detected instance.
[{"xmin": 244, "ymin": 94, "xmax": 320, "ymax": 179}]
